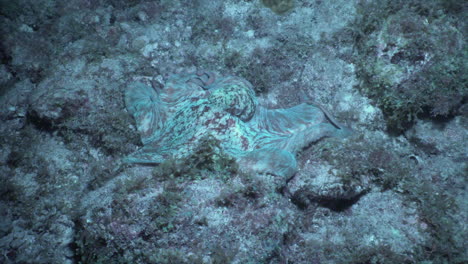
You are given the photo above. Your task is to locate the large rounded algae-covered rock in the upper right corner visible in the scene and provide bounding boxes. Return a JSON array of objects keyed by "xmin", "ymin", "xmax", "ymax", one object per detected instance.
[{"xmin": 356, "ymin": 1, "xmax": 468, "ymax": 131}]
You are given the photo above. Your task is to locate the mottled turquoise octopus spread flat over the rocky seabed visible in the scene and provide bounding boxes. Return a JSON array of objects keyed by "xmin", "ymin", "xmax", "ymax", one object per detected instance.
[{"xmin": 124, "ymin": 71, "xmax": 350, "ymax": 178}]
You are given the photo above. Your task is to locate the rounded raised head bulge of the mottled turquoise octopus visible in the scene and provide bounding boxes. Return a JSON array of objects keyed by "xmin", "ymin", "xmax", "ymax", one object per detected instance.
[{"xmin": 208, "ymin": 80, "xmax": 257, "ymax": 121}]
